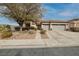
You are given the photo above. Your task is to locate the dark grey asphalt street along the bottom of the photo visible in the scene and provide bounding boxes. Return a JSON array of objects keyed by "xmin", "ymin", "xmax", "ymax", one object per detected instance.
[{"xmin": 0, "ymin": 47, "xmax": 79, "ymax": 56}]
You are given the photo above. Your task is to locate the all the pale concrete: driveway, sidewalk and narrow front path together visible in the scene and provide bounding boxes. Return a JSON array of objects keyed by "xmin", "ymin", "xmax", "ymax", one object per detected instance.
[{"xmin": 0, "ymin": 31, "xmax": 79, "ymax": 49}]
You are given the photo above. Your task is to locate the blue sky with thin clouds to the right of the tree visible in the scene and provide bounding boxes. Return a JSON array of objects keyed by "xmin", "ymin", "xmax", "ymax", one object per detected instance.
[{"xmin": 42, "ymin": 3, "xmax": 79, "ymax": 20}]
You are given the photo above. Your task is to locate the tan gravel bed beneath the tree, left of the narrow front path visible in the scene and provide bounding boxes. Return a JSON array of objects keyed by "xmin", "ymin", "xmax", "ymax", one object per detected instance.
[{"xmin": 0, "ymin": 31, "xmax": 36, "ymax": 40}]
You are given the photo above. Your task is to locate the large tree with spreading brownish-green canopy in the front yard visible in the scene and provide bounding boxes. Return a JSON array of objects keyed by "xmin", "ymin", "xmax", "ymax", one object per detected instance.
[{"xmin": 4, "ymin": 3, "xmax": 42, "ymax": 29}]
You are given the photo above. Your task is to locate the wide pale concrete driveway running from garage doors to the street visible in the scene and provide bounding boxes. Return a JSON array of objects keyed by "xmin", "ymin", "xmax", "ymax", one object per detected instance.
[{"xmin": 45, "ymin": 31, "xmax": 79, "ymax": 47}]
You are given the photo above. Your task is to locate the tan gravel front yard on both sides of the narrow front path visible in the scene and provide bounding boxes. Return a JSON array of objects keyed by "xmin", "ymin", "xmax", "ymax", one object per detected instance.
[{"xmin": 0, "ymin": 30, "xmax": 49, "ymax": 40}]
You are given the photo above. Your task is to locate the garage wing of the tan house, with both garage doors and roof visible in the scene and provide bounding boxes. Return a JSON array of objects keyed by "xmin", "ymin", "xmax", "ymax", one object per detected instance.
[{"xmin": 41, "ymin": 20, "xmax": 68, "ymax": 30}]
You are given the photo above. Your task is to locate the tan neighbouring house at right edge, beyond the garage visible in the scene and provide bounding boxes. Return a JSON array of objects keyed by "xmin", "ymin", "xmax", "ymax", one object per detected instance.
[{"xmin": 69, "ymin": 19, "xmax": 79, "ymax": 31}]
